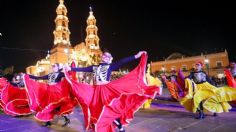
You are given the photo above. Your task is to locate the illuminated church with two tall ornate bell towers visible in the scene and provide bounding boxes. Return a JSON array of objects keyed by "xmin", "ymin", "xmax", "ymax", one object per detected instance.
[{"xmin": 26, "ymin": 0, "xmax": 102, "ymax": 75}]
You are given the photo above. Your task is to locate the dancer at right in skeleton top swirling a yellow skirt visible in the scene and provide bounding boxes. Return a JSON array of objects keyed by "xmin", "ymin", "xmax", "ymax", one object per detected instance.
[{"xmin": 180, "ymin": 61, "xmax": 236, "ymax": 119}]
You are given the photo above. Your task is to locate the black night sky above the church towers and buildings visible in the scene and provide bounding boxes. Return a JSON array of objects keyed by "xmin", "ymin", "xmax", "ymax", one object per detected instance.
[{"xmin": 0, "ymin": 0, "xmax": 236, "ymax": 71}]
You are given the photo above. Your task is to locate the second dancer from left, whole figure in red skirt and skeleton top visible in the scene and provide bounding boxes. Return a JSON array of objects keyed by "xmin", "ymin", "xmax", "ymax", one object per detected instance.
[{"xmin": 24, "ymin": 63, "xmax": 77, "ymax": 127}]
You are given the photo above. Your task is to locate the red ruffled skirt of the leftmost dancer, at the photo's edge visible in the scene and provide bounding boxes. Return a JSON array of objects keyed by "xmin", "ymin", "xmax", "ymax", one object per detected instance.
[{"xmin": 1, "ymin": 83, "xmax": 32, "ymax": 116}]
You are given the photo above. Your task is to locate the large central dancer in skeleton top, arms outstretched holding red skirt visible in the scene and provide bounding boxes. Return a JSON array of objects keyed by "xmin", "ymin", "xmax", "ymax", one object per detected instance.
[{"xmin": 66, "ymin": 52, "xmax": 160, "ymax": 132}]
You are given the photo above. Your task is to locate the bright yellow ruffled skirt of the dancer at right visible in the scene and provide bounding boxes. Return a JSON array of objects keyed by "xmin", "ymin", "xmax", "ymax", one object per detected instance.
[{"xmin": 180, "ymin": 79, "xmax": 236, "ymax": 113}]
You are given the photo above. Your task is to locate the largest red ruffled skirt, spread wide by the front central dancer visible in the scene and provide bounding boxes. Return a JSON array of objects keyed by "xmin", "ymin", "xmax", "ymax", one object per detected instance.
[{"xmin": 66, "ymin": 54, "xmax": 161, "ymax": 132}]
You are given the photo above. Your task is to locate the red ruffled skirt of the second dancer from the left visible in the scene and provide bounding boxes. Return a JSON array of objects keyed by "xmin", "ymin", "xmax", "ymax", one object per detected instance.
[{"xmin": 24, "ymin": 75, "xmax": 78, "ymax": 122}]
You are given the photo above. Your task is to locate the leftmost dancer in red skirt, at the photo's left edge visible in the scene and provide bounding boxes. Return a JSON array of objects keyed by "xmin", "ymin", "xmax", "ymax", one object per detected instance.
[{"xmin": 0, "ymin": 74, "xmax": 32, "ymax": 116}]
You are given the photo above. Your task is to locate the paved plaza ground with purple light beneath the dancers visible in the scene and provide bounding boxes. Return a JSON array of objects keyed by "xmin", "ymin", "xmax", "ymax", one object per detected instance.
[{"xmin": 0, "ymin": 89, "xmax": 236, "ymax": 132}]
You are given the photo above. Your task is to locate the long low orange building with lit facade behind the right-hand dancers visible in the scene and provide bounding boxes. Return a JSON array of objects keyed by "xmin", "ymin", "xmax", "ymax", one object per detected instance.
[{"xmin": 151, "ymin": 50, "xmax": 229, "ymax": 78}]
